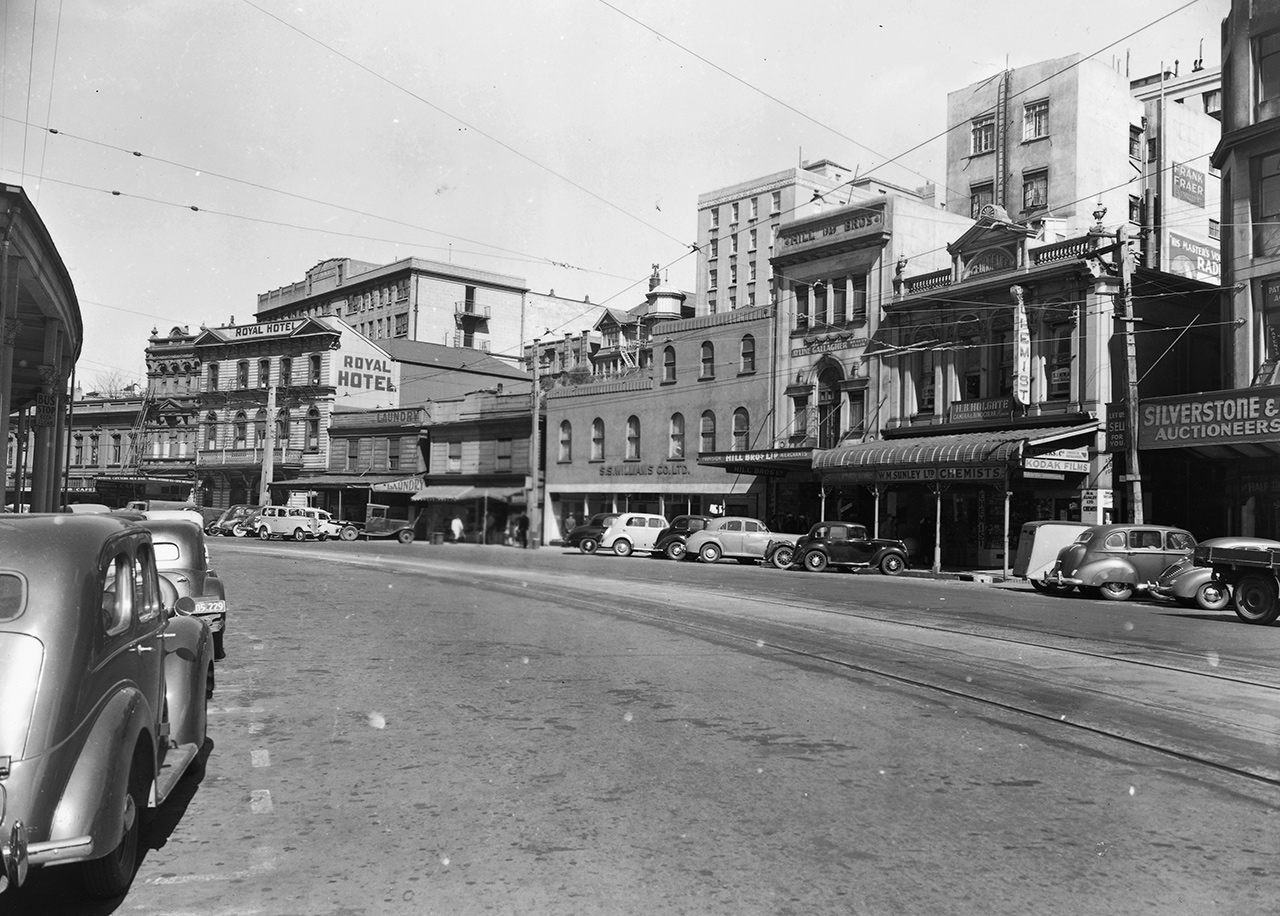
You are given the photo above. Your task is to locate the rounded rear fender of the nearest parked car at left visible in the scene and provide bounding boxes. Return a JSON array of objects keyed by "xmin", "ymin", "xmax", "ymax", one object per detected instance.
[{"xmin": 49, "ymin": 687, "xmax": 156, "ymax": 861}]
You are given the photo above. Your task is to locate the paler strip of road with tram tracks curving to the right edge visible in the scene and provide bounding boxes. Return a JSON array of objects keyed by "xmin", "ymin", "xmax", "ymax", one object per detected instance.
[{"xmin": 235, "ymin": 550, "xmax": 1280, "ymax": 787}]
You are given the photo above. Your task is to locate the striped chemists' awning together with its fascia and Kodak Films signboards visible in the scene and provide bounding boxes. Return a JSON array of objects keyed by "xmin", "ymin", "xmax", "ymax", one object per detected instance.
[{"xmin": 813, "ymin": 421, "xmax": 1098, "ymax": 484}]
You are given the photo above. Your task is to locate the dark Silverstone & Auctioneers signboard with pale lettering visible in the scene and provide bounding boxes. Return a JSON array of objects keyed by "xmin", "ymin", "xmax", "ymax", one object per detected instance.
[{"xmin": 1138, "ymin": 386, "xmax": 1280, "ymax": 449}]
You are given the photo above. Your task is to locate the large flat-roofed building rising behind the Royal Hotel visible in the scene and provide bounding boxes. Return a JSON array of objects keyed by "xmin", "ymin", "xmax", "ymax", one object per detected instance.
[{"xmin": 256, "ymin": 257, "xmax": 600, "ymax": 363}]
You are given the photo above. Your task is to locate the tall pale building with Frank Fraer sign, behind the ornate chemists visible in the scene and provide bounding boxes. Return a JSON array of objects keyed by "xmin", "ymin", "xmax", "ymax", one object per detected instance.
[{"xmin": 946, "ymin": 54, "xmax": 1221, "ymax": 283}]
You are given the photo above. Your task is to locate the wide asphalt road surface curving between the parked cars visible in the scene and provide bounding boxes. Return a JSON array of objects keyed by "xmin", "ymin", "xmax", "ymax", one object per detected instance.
[{"xmin": 5, "ymin": 541, "xmax": 1280, "ymax": 916}]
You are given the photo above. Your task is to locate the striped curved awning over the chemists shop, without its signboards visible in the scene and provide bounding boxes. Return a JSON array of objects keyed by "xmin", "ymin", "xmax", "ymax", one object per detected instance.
[{"xmin": 813, "ymin": 421, "xmax": 1098, "ymax": 475}]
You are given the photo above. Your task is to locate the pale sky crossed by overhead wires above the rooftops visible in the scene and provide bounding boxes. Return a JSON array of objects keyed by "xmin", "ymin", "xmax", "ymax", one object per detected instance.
[{"xmin": 0, "ymin": 0, "xmax": 1230, "ymax": 390}]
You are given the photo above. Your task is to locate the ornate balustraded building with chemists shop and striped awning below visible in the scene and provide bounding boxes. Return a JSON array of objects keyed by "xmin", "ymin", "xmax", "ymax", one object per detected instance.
[{"xmin": 813, "ymin": 211, "xmax": 1217, "ymax": 568}]
